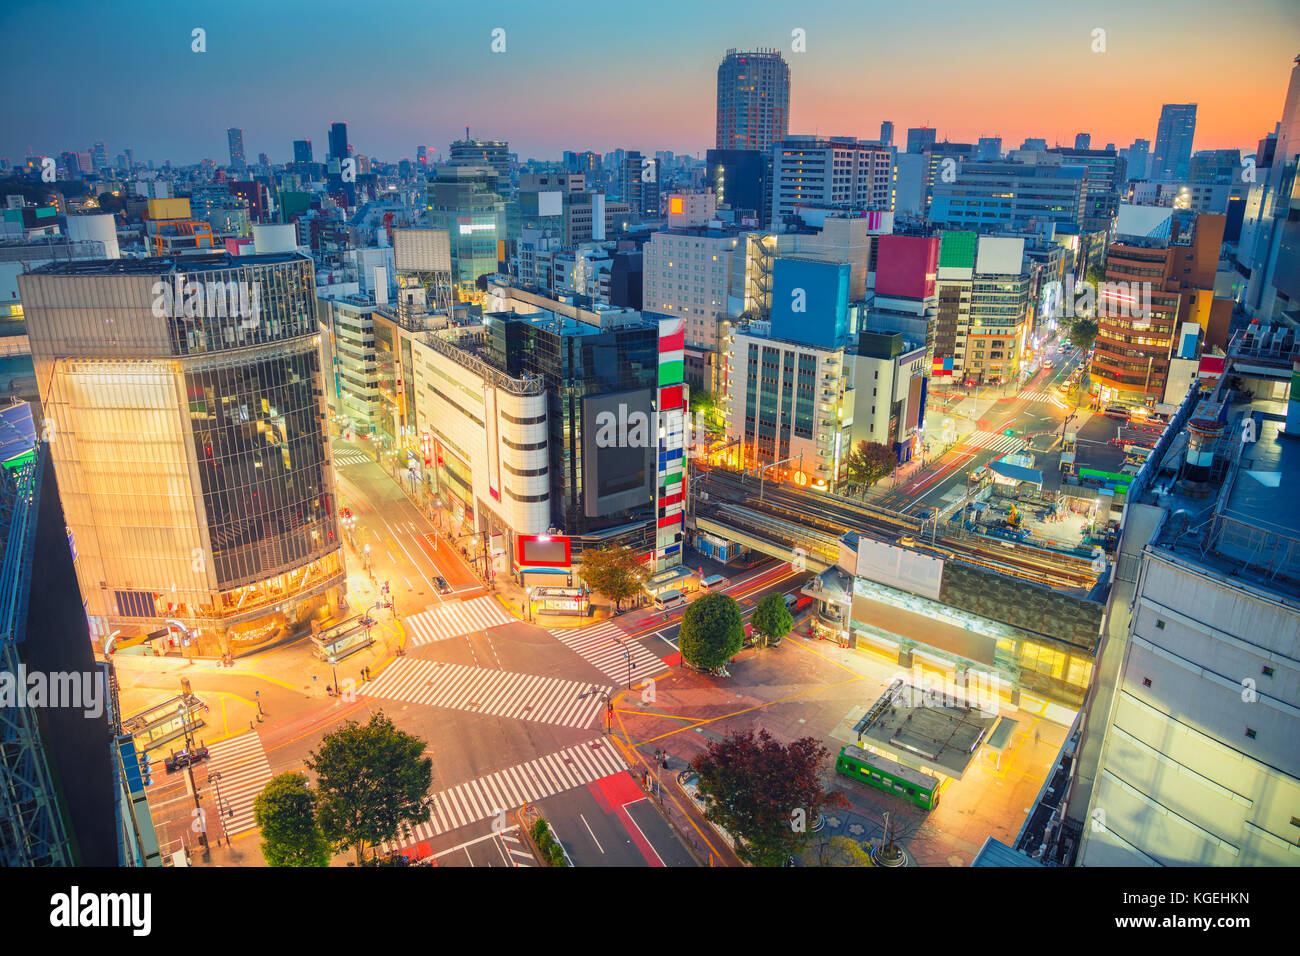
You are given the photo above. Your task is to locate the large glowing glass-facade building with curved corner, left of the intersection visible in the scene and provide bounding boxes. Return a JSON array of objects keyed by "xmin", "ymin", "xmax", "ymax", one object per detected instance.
[{"xmin": 20, "ymin": 254, "xmax": 345, "ymax": 656}]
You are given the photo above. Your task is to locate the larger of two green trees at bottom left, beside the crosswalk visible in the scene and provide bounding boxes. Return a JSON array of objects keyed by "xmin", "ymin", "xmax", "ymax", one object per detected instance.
[{"xmin": 307, "ymin": 713, "xmax": 433, "ymax": 862}]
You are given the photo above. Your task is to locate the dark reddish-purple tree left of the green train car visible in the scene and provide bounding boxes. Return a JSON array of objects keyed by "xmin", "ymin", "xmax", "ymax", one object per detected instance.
[{"xmin": 690, "ymin": 730, "xmax": 848, "ymax": 866}]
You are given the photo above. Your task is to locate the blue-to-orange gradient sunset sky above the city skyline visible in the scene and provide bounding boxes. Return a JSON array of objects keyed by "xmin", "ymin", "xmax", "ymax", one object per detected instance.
[{"xmin": 0, "ymin": 0, "xmax": 1300, "ymax": 164}]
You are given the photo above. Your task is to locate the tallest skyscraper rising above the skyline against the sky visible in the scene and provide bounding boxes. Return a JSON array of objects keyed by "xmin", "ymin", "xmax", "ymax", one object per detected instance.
[{"xmin": 715, "ymin": 49, "xmax": 790, "ymax": 151}]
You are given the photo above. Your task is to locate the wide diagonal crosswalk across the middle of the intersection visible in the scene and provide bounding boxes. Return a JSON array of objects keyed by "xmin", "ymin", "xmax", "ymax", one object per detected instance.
[{"xmin": 361, "ymin": 657, "xmax": 614, "ymax": 730}]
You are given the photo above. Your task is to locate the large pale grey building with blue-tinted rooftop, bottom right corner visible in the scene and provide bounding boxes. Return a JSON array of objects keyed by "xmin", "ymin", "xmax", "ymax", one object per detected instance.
[{"xmin": 1066, "ymin": 340, "xmax": 1300, "ymax": 873}]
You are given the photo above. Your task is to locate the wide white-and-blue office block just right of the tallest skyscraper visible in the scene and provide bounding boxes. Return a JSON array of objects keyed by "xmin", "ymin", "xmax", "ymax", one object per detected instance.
[{"xmin": 771, "ymin": 137, "xmax": 893, "ymax": 226}]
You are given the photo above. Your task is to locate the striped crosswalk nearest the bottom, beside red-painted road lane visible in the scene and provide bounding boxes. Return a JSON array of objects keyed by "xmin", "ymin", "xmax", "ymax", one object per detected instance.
[{"xmin": 382, "ymin": 737, "xmax": 627, "ymax": 852}]
